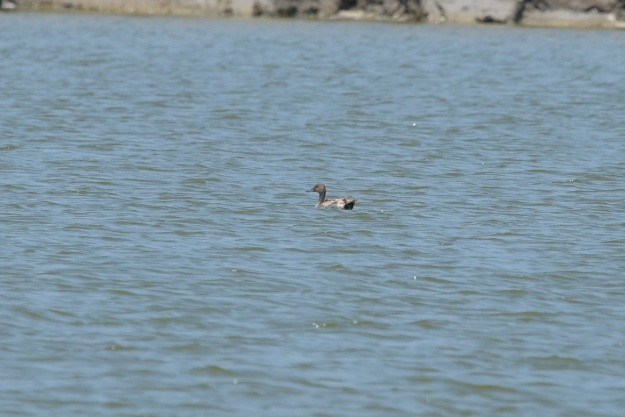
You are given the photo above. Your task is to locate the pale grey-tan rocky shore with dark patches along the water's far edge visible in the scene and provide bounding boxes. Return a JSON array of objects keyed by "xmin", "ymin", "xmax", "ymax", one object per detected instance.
[{"xmin": 7, "ymin": 0, "xmax": 625, "ymax": 28}]
